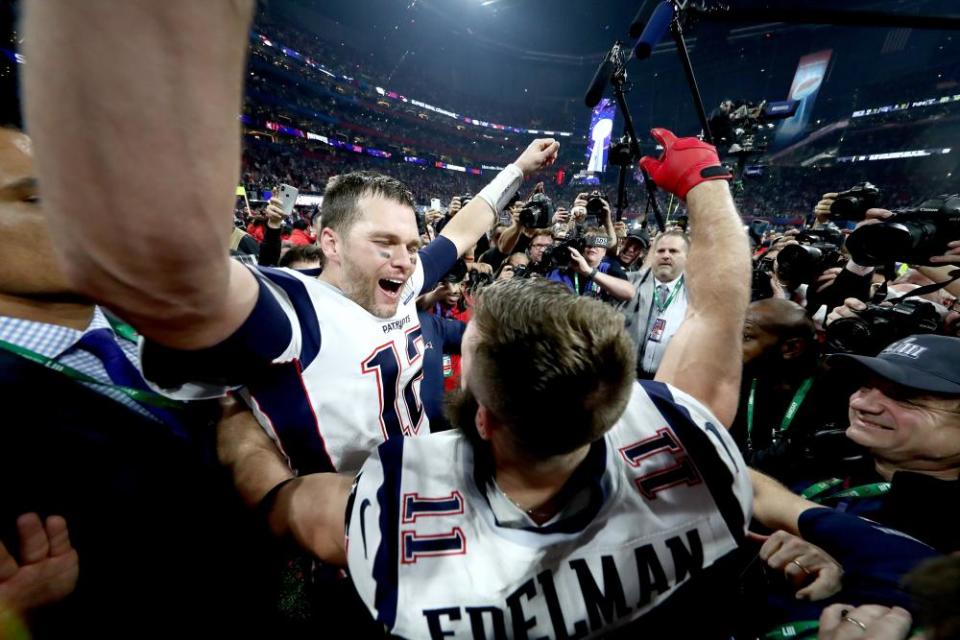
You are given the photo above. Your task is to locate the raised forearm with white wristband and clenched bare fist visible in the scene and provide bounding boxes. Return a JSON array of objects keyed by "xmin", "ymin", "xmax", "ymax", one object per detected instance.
[{"xmin": 440, "ymin": 138, "xmax": 560, "ymax": 255}]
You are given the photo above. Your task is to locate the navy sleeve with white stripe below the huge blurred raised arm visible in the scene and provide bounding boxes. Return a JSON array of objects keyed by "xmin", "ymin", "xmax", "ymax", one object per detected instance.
[{"xmin": 141, "ymin": 268, "xmax": 320, "ymax": 400}]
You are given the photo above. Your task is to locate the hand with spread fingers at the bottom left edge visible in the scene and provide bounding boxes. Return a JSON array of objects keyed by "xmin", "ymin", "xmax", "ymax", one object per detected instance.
[{"xmin": 0, "ymin": 513, "xmax": 80, "ymax": 613}]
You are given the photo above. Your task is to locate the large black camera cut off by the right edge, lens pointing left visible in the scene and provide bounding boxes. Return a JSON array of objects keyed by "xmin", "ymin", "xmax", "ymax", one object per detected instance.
[{"xmin": 847, "ymin": 194, "xmax": 960, "ymax": 266}]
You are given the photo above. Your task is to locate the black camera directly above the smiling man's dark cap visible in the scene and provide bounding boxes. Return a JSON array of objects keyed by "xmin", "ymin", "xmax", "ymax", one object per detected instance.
[{"xmin": 827, "ymin": 298, "xmax": 940, "ymax": 356}]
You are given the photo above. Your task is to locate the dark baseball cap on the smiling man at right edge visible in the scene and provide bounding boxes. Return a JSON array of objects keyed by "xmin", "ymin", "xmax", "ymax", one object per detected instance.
[{"xmin": 827, "ymin": 333, "xmax": 960, "ymax": 395}]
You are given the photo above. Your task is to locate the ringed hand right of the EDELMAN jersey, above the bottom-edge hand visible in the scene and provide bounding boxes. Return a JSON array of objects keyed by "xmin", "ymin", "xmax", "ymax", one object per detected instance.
[{"xmin": 759, "ymin": 531, "xmax": 843, "ymax": 600}]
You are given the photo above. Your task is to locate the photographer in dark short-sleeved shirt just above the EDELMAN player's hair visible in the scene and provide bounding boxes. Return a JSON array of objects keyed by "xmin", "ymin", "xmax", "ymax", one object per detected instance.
[{"xmin": 547, "ymin": 228, "xmax": 636, "ymax": 302}]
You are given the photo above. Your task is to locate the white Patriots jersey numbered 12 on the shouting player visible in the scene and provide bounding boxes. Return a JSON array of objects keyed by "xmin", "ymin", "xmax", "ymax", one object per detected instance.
[{"xmin": 143, "ymin": 252, "xmax": 430, "ymax": 475}]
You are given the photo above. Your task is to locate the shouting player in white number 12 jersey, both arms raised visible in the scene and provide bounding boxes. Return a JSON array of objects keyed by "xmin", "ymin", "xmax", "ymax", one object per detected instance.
[{"xmin": 18, "ymin": 0, "xmax": 559, "ymax": 502}]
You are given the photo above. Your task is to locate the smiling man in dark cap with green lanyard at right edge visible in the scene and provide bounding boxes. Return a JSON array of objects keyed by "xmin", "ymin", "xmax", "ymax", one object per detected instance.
[{"xmin": 802, "ymin": 334, "xmax": 960, "ymax": 553}]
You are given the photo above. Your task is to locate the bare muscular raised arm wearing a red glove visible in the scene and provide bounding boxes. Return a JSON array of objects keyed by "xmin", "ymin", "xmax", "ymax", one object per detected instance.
[{"xmin": 641, "ymin": 129, "xmax": 750, "ymax": 426}]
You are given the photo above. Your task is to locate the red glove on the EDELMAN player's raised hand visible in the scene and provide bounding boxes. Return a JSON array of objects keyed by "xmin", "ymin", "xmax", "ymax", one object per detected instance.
[{"xmin": 640, "ymin": 129, "xmax": 733, "ymax": 198}]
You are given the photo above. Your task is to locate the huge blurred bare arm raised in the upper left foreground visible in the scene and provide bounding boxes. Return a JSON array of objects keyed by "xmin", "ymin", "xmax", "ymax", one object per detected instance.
[{"xmin": 24, "ymin": 0, "xmax": 257, "ymax": 349}]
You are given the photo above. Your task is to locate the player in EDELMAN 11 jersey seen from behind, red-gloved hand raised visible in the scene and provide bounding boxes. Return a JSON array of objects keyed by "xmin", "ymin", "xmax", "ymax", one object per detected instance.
[{"xmin": 225, "ymin": 130, "xmax": 751, "ymax": 638}]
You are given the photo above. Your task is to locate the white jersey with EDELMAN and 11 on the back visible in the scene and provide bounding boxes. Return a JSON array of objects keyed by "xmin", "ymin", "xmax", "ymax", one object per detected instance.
[{"xmin": 347, "ymin": 382, "xmax": 752, "ymax": 638}]
